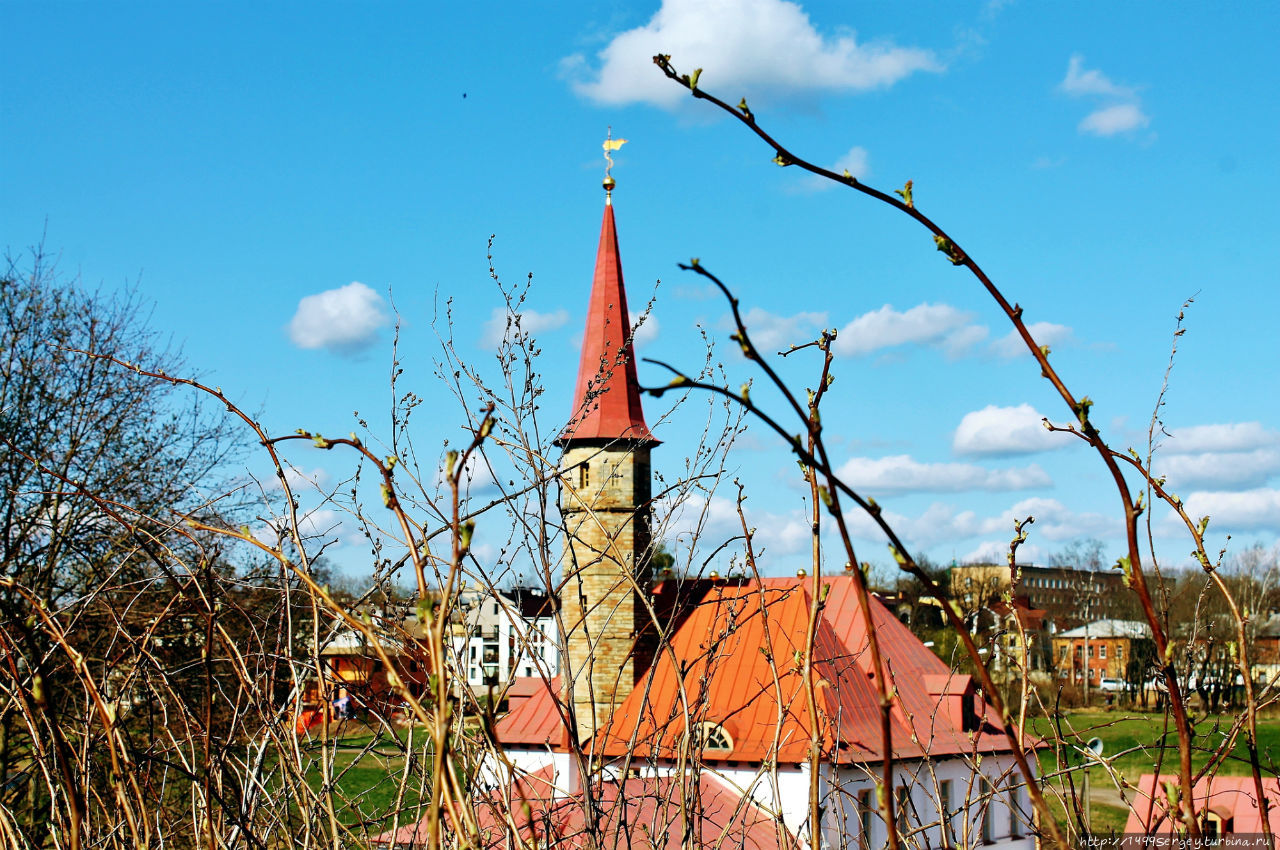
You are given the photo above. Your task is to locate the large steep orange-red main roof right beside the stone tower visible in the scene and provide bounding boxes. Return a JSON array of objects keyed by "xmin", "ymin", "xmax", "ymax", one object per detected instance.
[{"xmin": 498, "ymin": 576, "xmax": 1018, "ymax": 763}]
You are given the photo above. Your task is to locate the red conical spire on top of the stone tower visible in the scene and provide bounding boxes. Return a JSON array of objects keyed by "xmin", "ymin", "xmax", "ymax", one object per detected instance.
[{"xmin": 557, "ymin": 188, "xmax": 658, "ymax": 443}]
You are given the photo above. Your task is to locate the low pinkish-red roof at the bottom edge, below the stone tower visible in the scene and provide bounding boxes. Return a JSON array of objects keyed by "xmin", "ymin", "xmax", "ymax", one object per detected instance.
[{"xmin": 374, "ymin": 768, "xmax": 799, "ymax": 850}]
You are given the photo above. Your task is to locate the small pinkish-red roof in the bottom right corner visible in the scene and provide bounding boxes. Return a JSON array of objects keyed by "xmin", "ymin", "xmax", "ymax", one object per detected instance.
[{"xmin": 1124, "ymin": 773, "xmax": 1280, "ymax": 836}]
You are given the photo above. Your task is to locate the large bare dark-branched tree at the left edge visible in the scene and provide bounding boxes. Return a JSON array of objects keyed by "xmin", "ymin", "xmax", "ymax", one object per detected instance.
[{"xmin": 0, "ymin": 250, "xmax": 234, "ymax": 846}]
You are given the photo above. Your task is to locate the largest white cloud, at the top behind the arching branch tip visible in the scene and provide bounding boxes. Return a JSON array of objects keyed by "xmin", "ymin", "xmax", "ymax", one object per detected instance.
[{"xmin": 562, "ymin": 0, "xmax": 942, "ymax": 108}]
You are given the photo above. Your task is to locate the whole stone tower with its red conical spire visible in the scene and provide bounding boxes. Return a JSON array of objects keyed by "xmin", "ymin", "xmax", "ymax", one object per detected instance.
[{"xmin": 556, "ymin": 167, "xmax": 658, "ymax": 742}]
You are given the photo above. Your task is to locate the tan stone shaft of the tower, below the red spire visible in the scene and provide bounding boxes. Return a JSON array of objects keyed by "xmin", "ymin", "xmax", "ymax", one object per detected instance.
[{"xmin": 561, "ymin": 444, "xmax": 652, "ymax": 741}]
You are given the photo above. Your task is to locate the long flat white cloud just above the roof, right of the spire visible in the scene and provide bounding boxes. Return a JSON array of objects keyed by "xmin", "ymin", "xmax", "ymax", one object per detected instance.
[{"xmin": 840, "ymin": 454, "xmax": 1053, "ymax": 494}]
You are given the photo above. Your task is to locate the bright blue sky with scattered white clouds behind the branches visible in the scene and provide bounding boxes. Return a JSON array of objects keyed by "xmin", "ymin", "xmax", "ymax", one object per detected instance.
[{"xmin": 0, "ymin": 0, "xmax": 1280, "ymax": 581}]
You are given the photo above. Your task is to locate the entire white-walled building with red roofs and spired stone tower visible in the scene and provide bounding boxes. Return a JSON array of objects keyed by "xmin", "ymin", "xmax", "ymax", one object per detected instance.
[{"xmin": 379, "ymin": 167, "xmax": 1036, "ymax": 850}]
